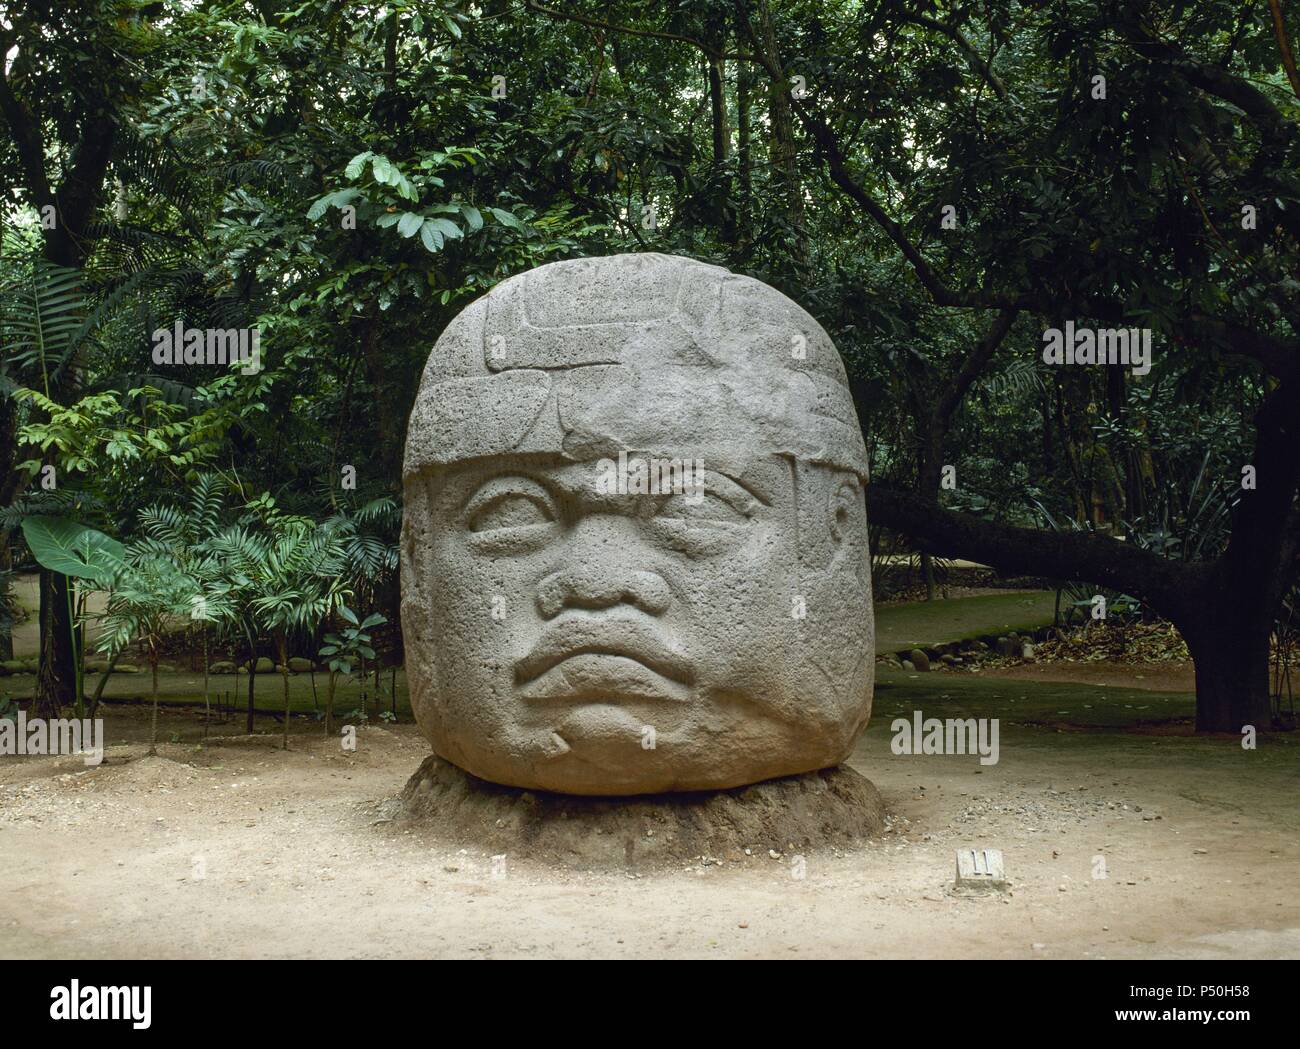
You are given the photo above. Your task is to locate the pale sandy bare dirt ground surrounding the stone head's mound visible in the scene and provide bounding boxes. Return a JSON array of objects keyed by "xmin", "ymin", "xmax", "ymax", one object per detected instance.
[{"xmin": 0, "ymin": 710, "xmax": 1300, "ymax": 958}]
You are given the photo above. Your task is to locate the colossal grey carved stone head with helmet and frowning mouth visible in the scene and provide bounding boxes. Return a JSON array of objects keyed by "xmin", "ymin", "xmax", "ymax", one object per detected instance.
[{"xmin": 402, "ymin": 253, "xmax": 874, "ymax": 794}]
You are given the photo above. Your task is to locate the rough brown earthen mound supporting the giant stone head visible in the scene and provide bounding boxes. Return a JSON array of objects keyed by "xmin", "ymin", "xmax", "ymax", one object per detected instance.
[{"xmin": 394, "ymin": 755, "xmax": 885, "ymax": 870}]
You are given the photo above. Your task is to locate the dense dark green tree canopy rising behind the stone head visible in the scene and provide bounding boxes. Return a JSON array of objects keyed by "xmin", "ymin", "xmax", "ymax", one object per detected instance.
[{"xmin": 0, "ymin": 0, "xmax": 1300, "ymax": 731}]
